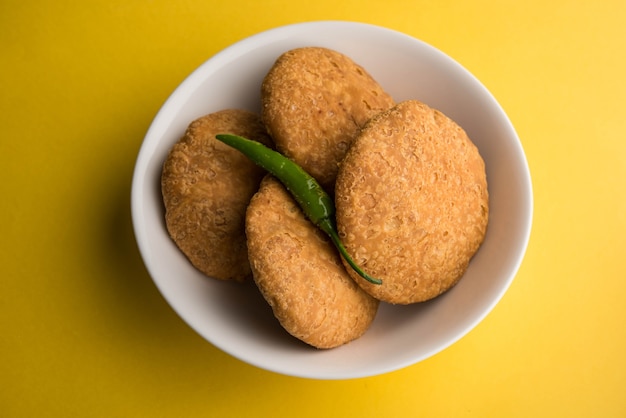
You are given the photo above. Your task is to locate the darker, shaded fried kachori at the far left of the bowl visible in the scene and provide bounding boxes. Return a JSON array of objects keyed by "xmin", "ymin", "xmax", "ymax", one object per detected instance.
[{"xmin": 161, "ymin": 109, "xmax": 271, "ymax": 281}]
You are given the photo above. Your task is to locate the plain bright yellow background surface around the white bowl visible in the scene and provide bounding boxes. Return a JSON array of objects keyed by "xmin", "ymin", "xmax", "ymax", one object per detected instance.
[{"xmin": 0, "ymin": 0, "xmax": 626, "ymax": 417}]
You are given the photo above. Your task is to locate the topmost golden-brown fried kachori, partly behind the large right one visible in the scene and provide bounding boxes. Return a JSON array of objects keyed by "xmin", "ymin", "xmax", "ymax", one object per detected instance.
[{"xmin": 261, "ymin": 47, "xmax": 394, "ymax": 192}]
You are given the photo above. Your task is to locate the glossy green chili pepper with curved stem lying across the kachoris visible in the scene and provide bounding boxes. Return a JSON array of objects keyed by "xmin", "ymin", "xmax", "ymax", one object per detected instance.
[{"xmin": 216, "ymin": 135, "xmax": 382, "ymax": 284}]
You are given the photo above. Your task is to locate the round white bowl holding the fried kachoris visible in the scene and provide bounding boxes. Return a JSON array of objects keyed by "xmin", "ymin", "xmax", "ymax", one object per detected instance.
[{"xmin": 132, "ymin": 21, "xmax": 533, "ymax": 379}]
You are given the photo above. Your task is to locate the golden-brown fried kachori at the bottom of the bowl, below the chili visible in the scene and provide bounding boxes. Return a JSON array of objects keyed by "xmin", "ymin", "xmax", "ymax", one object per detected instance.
[{"xmin": 246, "ymin": 175, "xmax": 379, "ymax": 348}]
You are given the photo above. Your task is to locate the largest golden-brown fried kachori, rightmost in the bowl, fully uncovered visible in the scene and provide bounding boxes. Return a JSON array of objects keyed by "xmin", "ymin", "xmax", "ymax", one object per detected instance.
[{"xmin": 335, "ymin": 101, "xmax": 489, "ymax": 304}]
